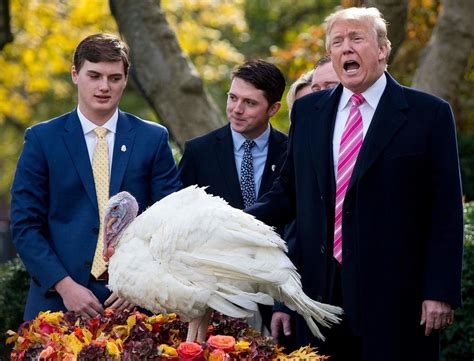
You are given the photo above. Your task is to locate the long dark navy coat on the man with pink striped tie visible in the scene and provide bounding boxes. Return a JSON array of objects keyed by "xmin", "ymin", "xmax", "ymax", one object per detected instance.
[{"xmin": 248, "ymin": 73, "xmax": 463, "ymax": 361}]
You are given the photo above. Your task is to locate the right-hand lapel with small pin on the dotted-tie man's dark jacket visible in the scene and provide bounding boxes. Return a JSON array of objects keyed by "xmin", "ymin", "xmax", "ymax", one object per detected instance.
[{"xmin": 258, "ymin": 128, "xmax": 286, "ymax": 197}]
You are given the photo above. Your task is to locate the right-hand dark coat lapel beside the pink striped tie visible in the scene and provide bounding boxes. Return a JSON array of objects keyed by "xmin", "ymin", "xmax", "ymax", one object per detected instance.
[{"xmin": 347, "ymin": 73, "xmax": 408, "ymax": 192}]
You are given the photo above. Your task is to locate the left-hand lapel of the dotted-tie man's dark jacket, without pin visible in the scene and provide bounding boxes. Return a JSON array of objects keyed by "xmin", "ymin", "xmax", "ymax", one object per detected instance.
[{"xmin": 215, "ymin": 124, "xmax": 244, "ymax": 208}]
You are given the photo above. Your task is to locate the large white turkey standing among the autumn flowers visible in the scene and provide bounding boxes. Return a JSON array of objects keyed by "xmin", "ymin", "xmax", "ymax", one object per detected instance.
[{"xmin": 104, "ymin": 186, "xmax": 342, "ymax": 341}]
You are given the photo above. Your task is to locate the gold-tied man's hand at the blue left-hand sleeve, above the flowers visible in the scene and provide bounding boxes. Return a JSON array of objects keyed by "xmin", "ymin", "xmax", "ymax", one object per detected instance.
[{"xmin": 54, "ymin": 276, "xmax": 104, "ymax": 318}]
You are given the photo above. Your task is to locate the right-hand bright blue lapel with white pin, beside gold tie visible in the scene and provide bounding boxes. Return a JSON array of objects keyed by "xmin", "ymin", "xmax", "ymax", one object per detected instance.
[{"xmin": 109, "ymin": 111, "xmax": 135, "ymax": 196}]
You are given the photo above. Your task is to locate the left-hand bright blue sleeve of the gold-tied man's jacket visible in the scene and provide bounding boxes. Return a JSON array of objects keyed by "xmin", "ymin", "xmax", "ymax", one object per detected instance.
[{"xmin": 11, "ymin": 129, "xmax": 68, "ymax": 294}]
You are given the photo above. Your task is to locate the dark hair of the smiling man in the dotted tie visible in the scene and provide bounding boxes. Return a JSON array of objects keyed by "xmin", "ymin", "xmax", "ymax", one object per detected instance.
[{"xmin": 232, "ymin": 59, "xmax": 286, "ymax": 105}]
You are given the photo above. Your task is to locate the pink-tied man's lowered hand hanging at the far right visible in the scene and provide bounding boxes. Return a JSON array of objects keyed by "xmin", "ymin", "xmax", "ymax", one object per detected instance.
[{"xmin": 420, "ymin": 300, "xmax": 454, "ymax": 336}]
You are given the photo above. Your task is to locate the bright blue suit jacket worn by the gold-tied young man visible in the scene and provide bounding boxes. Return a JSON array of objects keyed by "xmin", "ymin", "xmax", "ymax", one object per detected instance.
[{"xmin": 11, "ymin": 111, "xmax": 181, "ymax": 320}]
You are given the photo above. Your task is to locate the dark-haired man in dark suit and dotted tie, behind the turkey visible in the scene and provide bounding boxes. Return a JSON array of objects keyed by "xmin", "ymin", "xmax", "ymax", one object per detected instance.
[{"xmin": 179, "ymin": 60, "xmax": 287, "ymax": 327}]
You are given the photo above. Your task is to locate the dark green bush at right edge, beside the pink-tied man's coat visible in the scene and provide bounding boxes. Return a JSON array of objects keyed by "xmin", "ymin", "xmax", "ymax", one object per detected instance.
[{"xmin": 441, "ymin": 202, "xmax": 474, "ymax": 361}]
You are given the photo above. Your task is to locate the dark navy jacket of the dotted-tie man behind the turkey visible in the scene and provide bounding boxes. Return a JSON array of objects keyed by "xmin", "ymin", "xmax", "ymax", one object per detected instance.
[{"xmin": 179, "ymin": 124, "xmax": 287, "ymax": 209}]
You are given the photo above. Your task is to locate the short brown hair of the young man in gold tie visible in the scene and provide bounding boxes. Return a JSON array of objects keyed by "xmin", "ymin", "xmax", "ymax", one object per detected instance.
[{"xmin": 73, "ymin": 33, "xmax": 130, "ymax": 75}]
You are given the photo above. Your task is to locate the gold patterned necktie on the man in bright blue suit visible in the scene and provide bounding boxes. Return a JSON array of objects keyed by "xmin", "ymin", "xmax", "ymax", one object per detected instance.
[{"xmin": 91, "ymin": 127, "xmax": 109, "ymax": 278}]
